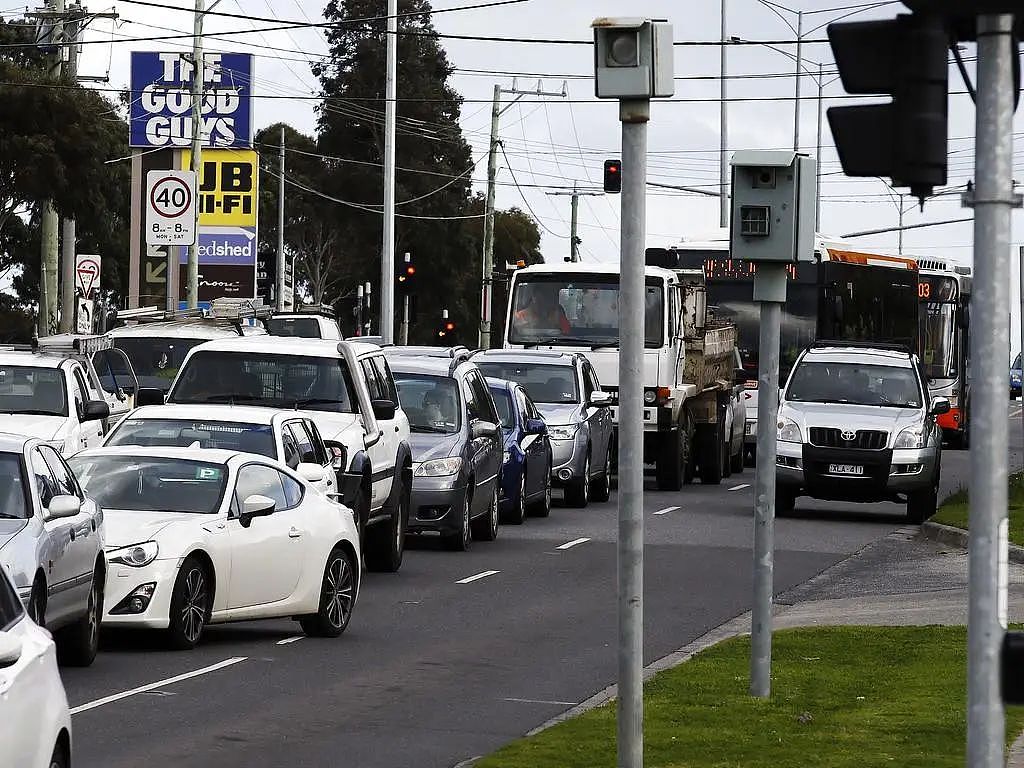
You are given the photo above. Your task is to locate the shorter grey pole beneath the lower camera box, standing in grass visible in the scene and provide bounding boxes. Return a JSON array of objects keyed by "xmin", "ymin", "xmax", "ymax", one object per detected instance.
[{"xmin": 751, "ymin": 263, "xmax": 786, "ymax": 698}]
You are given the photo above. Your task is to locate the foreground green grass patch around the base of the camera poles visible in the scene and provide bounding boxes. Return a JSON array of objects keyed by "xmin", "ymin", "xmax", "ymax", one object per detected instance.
[{"xmin": 476, "ymin": 627, "xmax": 1024, "ymax": 768}]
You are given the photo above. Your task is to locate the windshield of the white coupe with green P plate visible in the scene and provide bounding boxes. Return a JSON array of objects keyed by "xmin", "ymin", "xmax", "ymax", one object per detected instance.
[{"xmin": 68, "ymin": 456, "xmax": 227, "ymax": 515}]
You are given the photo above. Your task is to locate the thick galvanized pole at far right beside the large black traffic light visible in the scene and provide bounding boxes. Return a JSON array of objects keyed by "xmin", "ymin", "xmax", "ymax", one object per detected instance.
[{"xmin": 967, "ymin": 14, "xmax": 1015, "ymax": 768}]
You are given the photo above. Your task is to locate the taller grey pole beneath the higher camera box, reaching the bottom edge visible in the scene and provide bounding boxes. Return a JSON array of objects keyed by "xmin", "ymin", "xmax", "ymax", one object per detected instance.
[{"xmin": 618, "ymin": 99, "xmax": 650, "ymax": 768}]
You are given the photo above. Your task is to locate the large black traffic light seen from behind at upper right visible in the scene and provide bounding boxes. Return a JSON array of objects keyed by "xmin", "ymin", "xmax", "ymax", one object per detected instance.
[{"xmin": 828, "ymin": 13, "xmax": 951, "ymax": 205}]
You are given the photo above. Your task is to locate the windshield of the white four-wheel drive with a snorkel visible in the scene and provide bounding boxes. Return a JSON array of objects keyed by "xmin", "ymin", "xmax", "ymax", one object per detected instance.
[{"xmin": 168, "ymin": 350, "xmax": 357, "ymax": 414}]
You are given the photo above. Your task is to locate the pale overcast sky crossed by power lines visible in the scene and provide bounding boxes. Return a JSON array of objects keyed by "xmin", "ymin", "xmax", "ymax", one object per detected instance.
[{"xmin": 64, "ymin": 0, "xmax": 1024, "ymax": 347}]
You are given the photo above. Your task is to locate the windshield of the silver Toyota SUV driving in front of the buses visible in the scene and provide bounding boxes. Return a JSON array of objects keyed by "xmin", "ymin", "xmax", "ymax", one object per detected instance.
[{"xmin": 785, "ymin": 362, "xmax": 922, "ymax": 408}]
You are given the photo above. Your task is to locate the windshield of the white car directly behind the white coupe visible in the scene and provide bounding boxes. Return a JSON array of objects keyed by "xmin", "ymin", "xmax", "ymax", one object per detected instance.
[{"xmin": 105, "ymin": 418, "xmax": 278, "ymax": 459}]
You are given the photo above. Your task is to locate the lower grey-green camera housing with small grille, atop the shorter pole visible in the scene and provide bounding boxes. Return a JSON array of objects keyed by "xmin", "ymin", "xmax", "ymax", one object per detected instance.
[{"xmin": 729, "ymin": 150, "xmax": 817, "ymax": 264}]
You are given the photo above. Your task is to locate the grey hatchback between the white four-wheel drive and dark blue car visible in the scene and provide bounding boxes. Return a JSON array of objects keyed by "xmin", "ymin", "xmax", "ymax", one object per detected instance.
[{"xmin": 389, "ymin": 355, "xmax": 503, "ymax": 551}]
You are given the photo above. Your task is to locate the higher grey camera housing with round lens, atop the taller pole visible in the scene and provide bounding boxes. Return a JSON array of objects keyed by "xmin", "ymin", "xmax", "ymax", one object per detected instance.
[{"xmin": 591, "ymin": 17, "xmax": 676, "ymax": 99}]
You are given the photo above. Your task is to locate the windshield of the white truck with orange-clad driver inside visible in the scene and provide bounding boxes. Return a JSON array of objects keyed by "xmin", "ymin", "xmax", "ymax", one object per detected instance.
[{"xmin": 508, "ymin": 274, "xmax": 666, "ymax": 348}]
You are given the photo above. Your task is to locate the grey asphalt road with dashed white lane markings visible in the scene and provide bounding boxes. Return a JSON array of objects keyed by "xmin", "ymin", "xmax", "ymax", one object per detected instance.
[{"xmin": 62, "ymin": 407, "xmax": 1022, "ymax": 768}]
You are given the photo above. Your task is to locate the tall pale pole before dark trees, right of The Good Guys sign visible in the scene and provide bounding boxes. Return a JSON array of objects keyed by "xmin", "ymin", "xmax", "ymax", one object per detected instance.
[{"xmin": 380, "ymin": 0, "xmax": 398, "ymax": 344}]
